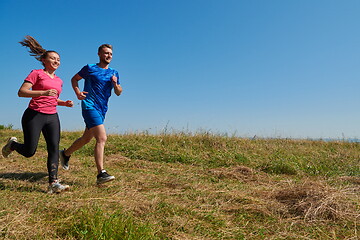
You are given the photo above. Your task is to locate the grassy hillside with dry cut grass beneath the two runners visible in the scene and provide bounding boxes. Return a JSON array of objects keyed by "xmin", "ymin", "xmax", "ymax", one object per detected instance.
[{"xmin": 0, "ymin": 129, "xmax": 360, "ymax": 239}]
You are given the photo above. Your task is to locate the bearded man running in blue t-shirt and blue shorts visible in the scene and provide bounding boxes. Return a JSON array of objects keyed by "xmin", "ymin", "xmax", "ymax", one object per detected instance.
[{"xmin": 60, "ymin": 44, "xmax": 122, "ymax": 184}]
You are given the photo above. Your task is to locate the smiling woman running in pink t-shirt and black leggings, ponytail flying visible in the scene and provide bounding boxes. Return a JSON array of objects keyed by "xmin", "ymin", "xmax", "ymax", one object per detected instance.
[{"xmin": 2, "ymin": 36, "xmax": 73, "ymax": 193}]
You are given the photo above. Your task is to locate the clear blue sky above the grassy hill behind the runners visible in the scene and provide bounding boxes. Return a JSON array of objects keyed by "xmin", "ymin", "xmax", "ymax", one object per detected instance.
[{"xmin": 0, "ymin": 0, "xmax": 360, "ymax": 138}]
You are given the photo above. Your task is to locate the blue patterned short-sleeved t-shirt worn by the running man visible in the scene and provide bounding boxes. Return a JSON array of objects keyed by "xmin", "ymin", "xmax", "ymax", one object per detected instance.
[{"xmin": 78, "ymin": 64, "xmax": 120, "ymax": 116}]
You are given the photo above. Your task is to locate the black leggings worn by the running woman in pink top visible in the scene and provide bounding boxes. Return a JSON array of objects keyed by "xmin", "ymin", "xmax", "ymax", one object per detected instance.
[{"xmin": 11, "ymin": 108, "xmax": 60, "ymax": 183}]
